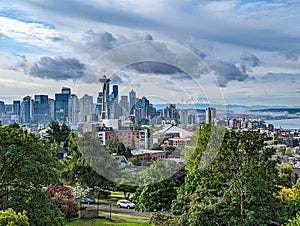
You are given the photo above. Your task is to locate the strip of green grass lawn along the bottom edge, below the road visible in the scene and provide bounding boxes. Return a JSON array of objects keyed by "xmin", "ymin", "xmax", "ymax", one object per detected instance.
[{"xmin": 67, "ymin": 218, "xmax": 150, "ymax": 226}]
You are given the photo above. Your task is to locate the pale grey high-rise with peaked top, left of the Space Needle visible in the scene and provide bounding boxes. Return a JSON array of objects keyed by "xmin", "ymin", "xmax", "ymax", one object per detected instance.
[{"xmin": 79, "ymin": 94, "xmax": 94, "ymax": 122}]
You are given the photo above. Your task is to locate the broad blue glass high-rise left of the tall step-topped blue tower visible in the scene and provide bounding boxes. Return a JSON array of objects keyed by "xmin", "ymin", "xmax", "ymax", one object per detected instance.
[{"xmin": 33, "ymin": 95, "xmax": 50, "ymax": 123}]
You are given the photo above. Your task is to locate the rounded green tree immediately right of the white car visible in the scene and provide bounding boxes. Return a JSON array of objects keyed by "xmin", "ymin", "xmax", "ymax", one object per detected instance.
[{"xmin": 133, "ymin": 161, "xmax": 176, "ymax": 211}]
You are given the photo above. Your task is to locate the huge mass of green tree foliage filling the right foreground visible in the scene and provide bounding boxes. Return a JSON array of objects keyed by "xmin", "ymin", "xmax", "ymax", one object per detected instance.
[{"xmin": 172, "ymin": 125, "xmax": 282, "ymax": 225}]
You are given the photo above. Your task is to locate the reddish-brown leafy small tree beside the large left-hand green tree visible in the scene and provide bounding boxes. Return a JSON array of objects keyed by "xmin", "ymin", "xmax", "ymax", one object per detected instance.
[{"xmin": 46, "ymin": 183, "xmax": 78, "ymax": 219}]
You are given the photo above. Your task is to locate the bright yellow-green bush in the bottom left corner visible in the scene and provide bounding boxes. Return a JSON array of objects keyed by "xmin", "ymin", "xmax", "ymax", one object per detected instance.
[{"xmin": 0, "ymin": 208, "xmax": 29, "ymax": 226}]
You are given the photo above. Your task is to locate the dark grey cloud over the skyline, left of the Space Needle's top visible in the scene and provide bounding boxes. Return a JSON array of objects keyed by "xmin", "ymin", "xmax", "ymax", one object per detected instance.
[{"xmin": 27, "ymin": 57, "xmax": 86, "ymax": 80}]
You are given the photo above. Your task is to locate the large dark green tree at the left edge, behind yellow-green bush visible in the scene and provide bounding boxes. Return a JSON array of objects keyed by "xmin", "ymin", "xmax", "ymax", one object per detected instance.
[{"xmin": 0, "ymin": 125, "xmax": 64, "ymax": 225}]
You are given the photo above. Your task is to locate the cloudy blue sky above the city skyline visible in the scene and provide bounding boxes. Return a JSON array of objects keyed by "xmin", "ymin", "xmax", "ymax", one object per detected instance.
[{"xmin": 0, "ymin": 0, "xmax": 300, "ymax": 106}]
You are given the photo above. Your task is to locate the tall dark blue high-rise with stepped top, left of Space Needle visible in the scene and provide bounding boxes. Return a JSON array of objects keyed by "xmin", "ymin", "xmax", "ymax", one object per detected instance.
[{"xmin": 54, "ymin": 87, "xmax": 71, "ymax": 122}]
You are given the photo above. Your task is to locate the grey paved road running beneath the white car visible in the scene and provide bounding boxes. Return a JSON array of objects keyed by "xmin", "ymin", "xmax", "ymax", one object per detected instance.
[{"xmin": 83, "ymin": 204, "xmax": 152, "ymax": 217}]
